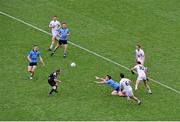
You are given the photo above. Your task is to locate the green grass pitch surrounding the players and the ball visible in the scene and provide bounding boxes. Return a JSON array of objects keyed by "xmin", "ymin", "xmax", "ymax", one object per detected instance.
[{"xmin": 0, "ymin": 0, "xmax": 180, "ymax": 121}]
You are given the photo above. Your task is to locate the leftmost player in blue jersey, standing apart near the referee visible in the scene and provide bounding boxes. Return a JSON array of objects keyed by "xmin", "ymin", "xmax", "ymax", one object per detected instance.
[{"xmin": 27, "ymin": 45, "xmax": 45, "ymax": 80}]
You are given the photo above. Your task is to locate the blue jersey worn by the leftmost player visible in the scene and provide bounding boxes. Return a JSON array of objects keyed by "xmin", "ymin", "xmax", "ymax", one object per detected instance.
[{"xmin": 29, "ymin": 50, "xmax": 40, "ymax": 63}]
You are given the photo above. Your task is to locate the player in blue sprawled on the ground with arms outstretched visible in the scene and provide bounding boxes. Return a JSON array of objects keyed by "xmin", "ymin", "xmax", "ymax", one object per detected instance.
[{"xmin": 95, "ymin": 75, "xmax": 126, "ymax": 96}]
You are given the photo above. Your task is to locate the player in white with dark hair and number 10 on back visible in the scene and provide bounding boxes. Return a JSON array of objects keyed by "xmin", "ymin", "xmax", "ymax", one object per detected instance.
[{"xmin": 131, "ymin": 61, "xmax": 152, "ymax": 94}]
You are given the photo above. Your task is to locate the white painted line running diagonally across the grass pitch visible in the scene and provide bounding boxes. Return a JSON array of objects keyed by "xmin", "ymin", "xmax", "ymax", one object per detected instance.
[{"xmin": 0, "ymin": 11, "xmax": 180, "ymax": 94}]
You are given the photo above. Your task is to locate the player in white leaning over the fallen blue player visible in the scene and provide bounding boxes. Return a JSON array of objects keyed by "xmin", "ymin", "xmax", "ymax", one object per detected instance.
[{"xmin": 119, "ymin": 73, "xmax": 141, "ymax": 105}]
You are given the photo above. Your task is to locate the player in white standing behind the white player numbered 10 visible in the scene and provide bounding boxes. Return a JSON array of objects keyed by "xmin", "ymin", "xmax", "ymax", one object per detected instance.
[{"xmin": 136, "ymin": 44, "xmax": 145, "ymax": 65}]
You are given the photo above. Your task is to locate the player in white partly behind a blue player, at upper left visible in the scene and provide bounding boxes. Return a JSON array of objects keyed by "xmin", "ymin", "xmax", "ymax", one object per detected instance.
[{"xmin": 49, "ymin": 16, "xmax": 61, "ymax": 51}]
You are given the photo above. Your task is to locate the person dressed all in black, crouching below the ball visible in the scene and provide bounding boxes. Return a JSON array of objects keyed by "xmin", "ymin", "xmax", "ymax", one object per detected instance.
[{"xmin": 48, "ymin": 69, "xmax": 61, "ymax": 95}]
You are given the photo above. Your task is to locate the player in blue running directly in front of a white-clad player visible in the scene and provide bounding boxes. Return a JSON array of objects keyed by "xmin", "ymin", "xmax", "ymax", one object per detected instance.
[{"xmin": 51, "ymin": 23, "xmax": 70, "ymax": 58}]
